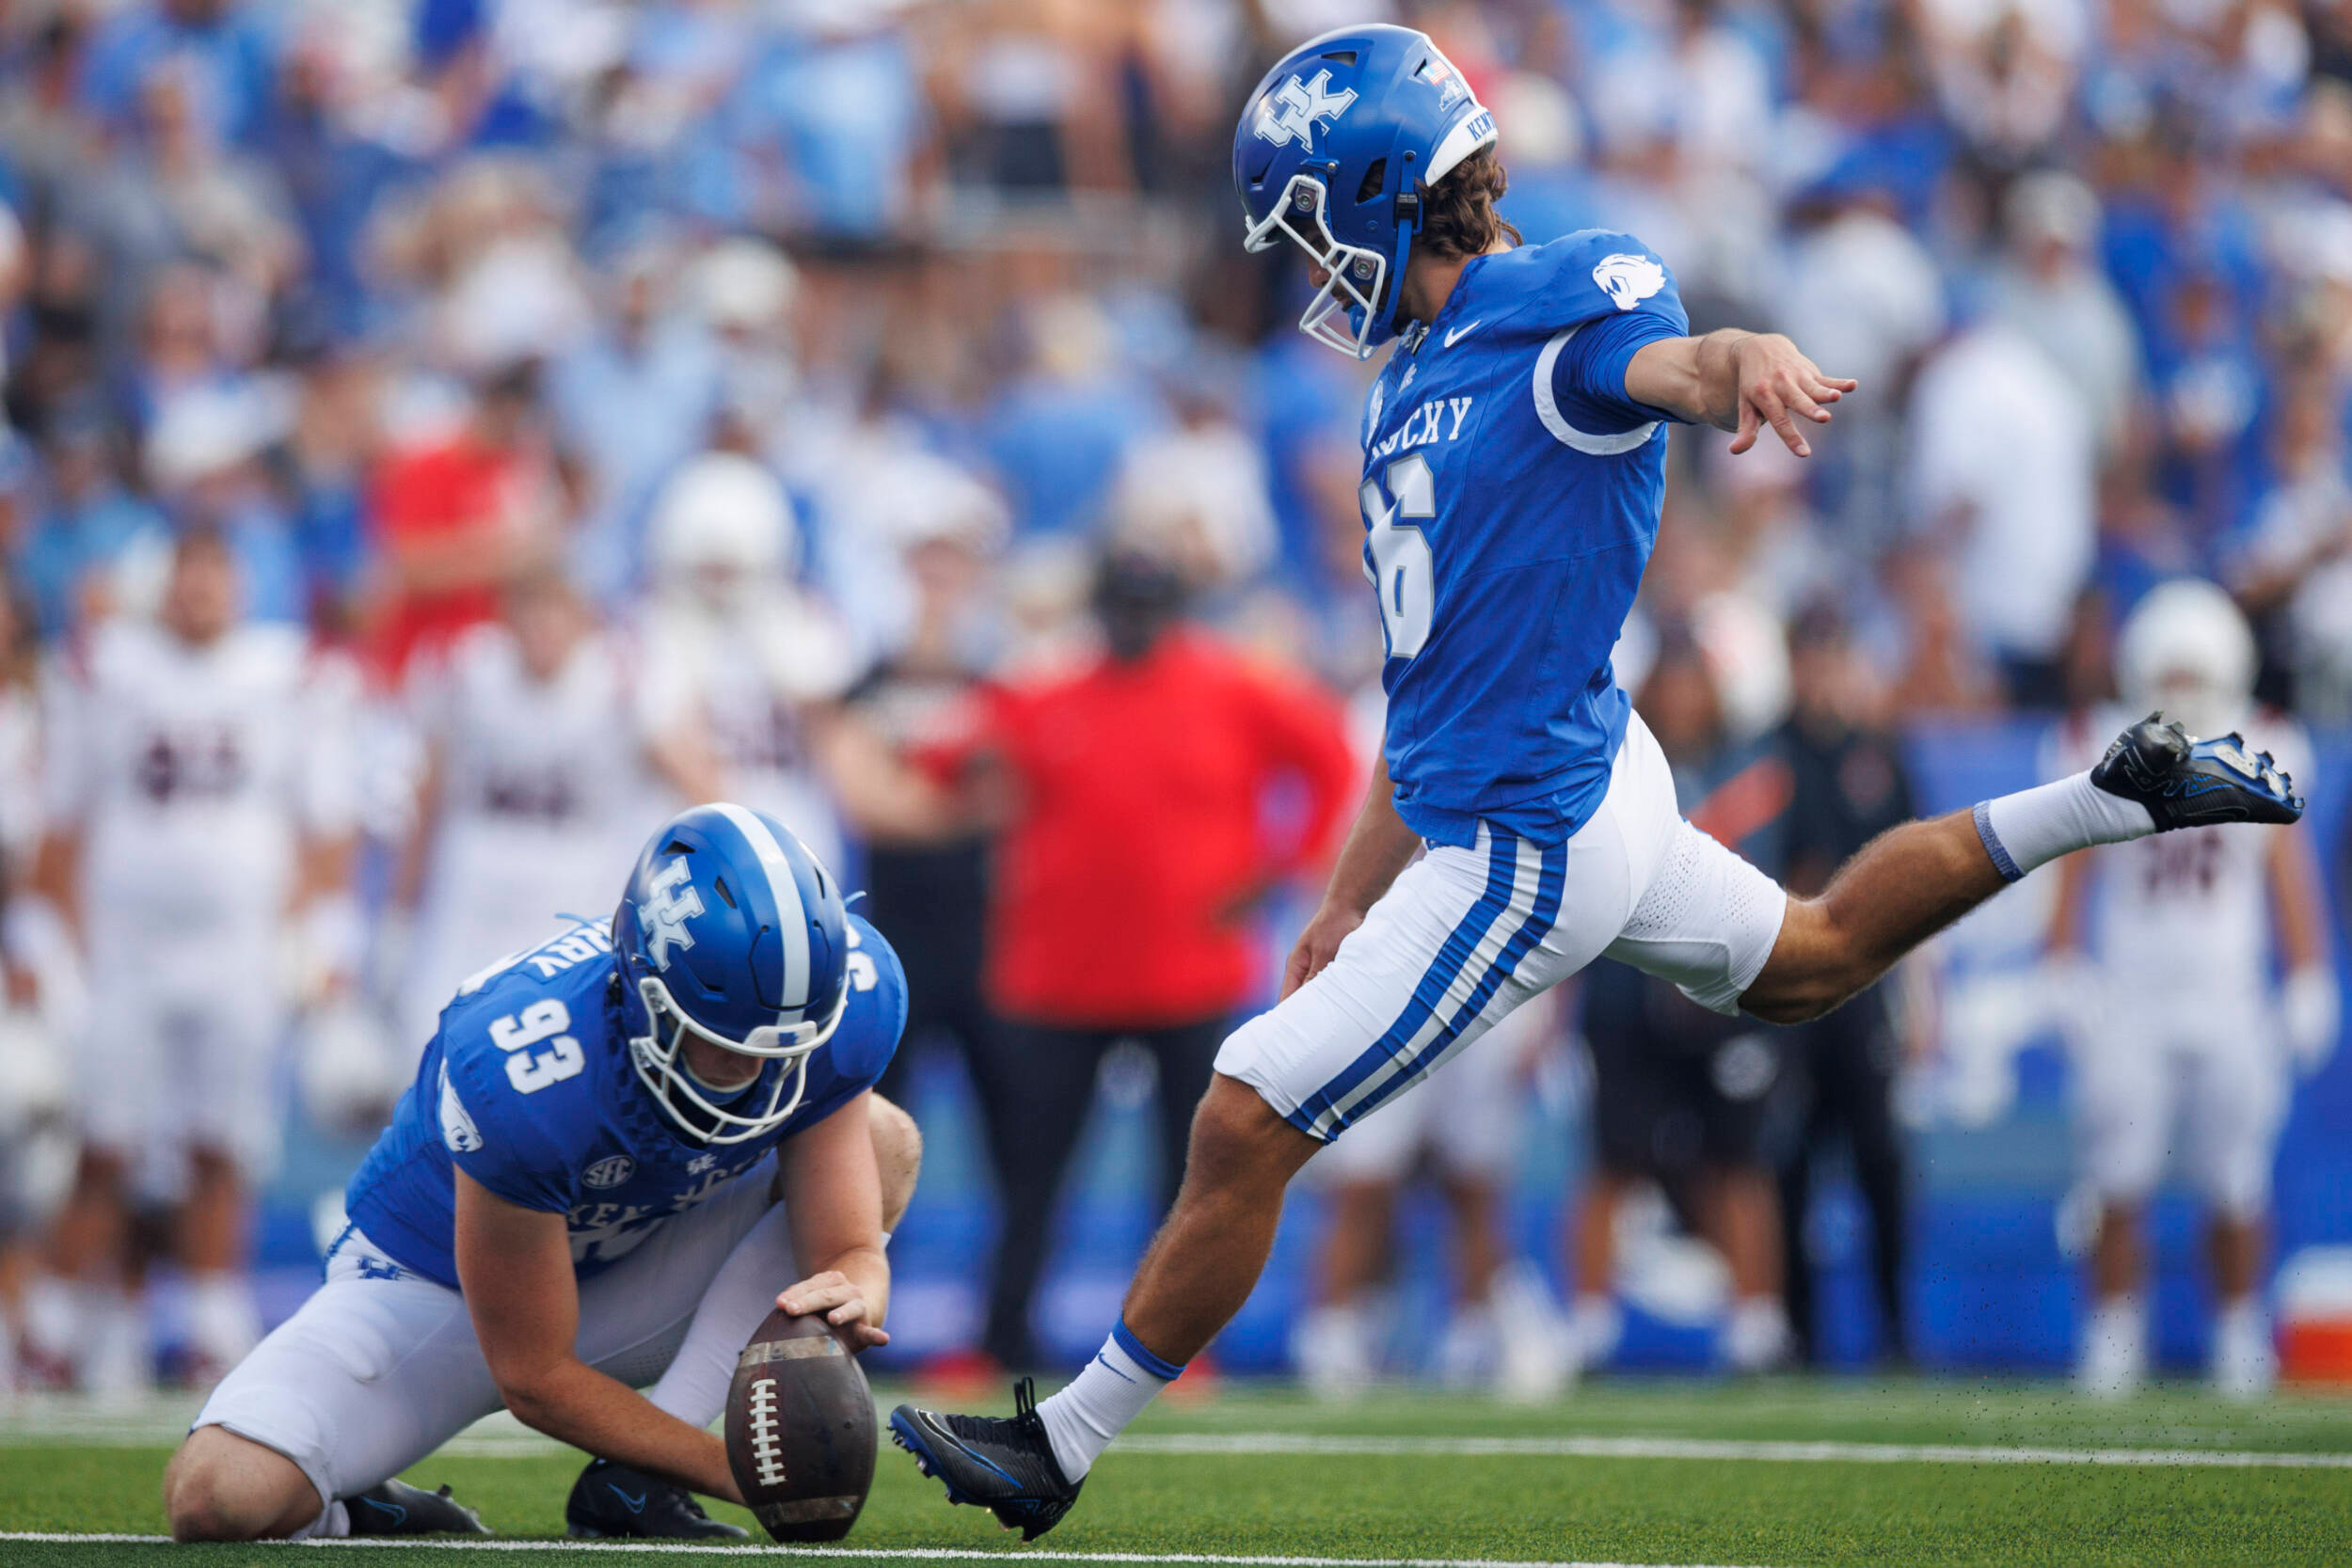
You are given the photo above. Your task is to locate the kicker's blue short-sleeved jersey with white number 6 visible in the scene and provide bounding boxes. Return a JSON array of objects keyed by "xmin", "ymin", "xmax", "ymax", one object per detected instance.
[{"xmin": 1359, "ymin": 230, "xmax": 1689, "ymax": 847}]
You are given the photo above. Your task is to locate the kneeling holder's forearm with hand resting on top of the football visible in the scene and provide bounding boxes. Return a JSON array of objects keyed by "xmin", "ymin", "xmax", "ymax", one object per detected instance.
[{"xmin": 776, "ymin": 1093, "xmax": 889, "ymax": 1350}]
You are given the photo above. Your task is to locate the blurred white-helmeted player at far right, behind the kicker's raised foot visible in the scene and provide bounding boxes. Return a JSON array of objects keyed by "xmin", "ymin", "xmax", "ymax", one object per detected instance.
[{"xmin": 2051, "ymin": 578, "xmax": 2338, "ymax": 1399}]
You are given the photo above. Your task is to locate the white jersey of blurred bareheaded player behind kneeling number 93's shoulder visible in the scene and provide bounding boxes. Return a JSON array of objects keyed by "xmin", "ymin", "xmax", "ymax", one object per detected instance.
[{"xmin": 405, "ymin": 623, "xmax": 659, "ymax": 1046}]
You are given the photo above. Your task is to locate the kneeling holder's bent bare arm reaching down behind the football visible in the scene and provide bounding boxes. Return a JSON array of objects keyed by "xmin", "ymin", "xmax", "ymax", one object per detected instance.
[{"xmin": 442, "ymin": 1171, "xmax": 743, "ymax": 1502}]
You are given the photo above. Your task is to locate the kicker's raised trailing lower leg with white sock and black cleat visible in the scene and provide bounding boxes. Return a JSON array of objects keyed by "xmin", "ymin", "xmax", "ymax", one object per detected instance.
[{"xmin": 1739, "ymin": 720, "xmax": 2303, "ymax": 1022}]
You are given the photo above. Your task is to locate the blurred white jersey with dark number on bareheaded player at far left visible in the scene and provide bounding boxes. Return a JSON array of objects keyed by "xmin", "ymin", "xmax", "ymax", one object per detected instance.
[{"xmin": 45, "ymin": 621, "xmax": 353, "ymax": 961}]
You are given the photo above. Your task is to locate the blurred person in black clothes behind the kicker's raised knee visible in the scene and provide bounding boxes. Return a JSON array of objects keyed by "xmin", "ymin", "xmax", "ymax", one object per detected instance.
[{"xmin": 1764, "ymin": 607, "xmax": 1919, "ymax": 1366}]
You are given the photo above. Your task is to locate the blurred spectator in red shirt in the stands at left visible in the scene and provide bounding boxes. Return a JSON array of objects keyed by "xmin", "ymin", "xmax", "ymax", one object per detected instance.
[{"xmin": 370, "ymin": 359, "xmax": 563, "ymax": 684}]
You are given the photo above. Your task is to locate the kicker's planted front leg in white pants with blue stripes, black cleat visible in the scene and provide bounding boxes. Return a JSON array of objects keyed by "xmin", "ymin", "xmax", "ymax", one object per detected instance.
[{"xmin": 892, "ymin": 808, "xmax": 1673, "ymax": 1538}]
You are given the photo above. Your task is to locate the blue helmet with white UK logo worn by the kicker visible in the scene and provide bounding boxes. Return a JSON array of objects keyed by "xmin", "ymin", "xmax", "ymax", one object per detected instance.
[{"xmin": 1232, "ymin": 24, "xmax": 1496, "ymax": 359}]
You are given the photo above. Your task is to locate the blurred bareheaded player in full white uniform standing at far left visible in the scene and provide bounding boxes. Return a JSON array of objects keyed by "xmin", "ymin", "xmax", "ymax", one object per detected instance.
[{"xmin": 28, "ymin": 531, "xmax": 358, "ymax": 1392}]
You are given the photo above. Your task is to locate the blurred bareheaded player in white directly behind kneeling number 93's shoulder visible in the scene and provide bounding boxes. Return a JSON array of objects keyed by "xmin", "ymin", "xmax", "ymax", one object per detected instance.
[{"xmin": 386, "ymin": 564, "xmax": 704, "ymax": 1077}]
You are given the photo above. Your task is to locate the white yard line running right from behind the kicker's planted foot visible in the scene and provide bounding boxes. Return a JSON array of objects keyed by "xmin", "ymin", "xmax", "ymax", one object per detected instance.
[{"xmin": 1113, "ymin": 1432, "xmax": 2352, "ymax": 1469}]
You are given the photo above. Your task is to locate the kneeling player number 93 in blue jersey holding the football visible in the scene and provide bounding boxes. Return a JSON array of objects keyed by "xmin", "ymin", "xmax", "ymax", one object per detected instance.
[{"xmin": 165, "ymin": 804, "xmax": 917, "ymax": 1540}]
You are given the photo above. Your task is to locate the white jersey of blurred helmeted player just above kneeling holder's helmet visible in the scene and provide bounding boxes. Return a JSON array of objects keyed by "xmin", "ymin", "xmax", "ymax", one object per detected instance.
[{"xmin": 640, "ymin": 590, "xmax": 856, "ymax": 865}]
